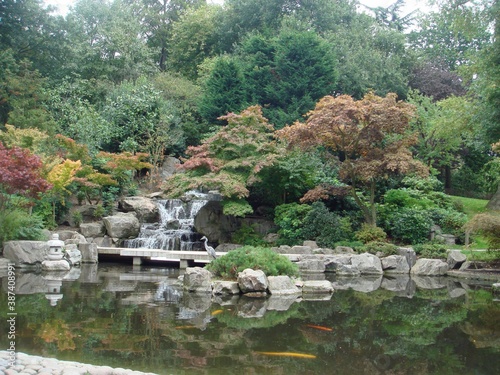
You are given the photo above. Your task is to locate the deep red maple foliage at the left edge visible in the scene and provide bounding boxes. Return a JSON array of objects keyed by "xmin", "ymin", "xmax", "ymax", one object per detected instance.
[{"xmin": 0, "ymin": 142, "xmax": 52, "ymax": 203}]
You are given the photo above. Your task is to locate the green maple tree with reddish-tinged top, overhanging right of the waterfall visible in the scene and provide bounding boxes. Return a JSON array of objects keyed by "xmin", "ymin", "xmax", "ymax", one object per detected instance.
[{"xmin": 164, "ymin": 106, "xmax": 280, "ymax": 216}]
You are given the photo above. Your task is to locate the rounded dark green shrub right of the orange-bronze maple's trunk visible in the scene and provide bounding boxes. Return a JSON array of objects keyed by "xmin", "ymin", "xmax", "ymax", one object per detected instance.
[{"xmin": 389, "ymin": 208, "xmax": 433, "ymax": 244}]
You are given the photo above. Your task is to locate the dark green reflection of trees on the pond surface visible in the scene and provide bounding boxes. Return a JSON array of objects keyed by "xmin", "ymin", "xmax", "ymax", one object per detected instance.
[{"xmin": 0, "ymin": 274, "xmax": 500, "ymax": 374}]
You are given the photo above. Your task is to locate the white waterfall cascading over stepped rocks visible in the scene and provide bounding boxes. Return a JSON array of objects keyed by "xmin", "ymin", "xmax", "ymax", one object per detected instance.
[{"xmin": 125, "ymin": 194, "xmax": 208, "ymax": 251}]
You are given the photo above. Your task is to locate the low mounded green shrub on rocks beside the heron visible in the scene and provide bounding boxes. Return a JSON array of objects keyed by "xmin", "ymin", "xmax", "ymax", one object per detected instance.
[{"xmin": 206, "ymin": 246, "xmax": 299, "ymax": 280}]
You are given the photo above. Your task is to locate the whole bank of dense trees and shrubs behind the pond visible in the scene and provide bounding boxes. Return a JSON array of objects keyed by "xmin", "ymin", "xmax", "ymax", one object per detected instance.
[{"xmin": 0, "ymin": 0, "xmax": 500, "ymax": 250}]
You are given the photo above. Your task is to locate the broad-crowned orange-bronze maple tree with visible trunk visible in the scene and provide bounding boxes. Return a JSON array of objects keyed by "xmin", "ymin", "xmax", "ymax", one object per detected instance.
[{"xmin": 277, "ymin": 93, "xmax": 427, "ymax": 225}]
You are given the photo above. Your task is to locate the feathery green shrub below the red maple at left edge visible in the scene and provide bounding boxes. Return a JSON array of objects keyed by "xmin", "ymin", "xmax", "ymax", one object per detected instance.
[{"xmin": 0, "ymin": 209, "xmax": 44, "ymax": 246}]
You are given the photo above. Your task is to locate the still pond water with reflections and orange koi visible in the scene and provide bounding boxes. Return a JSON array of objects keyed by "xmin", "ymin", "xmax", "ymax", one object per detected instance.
[{"xmin": 0, "ymin": 263, "xmax": 500, "ymax": 375}]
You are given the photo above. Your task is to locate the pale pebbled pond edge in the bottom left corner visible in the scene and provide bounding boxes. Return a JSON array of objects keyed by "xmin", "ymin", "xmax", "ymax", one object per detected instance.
[{"xmin": 0, "ymin": 350, "xmax": 157, "ymax": 375}]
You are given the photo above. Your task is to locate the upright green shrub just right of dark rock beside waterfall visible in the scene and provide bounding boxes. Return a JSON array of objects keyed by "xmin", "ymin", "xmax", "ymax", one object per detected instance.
[{"xmin": 274, "ymin": 203, "xmax": 312, "ymax": 245}]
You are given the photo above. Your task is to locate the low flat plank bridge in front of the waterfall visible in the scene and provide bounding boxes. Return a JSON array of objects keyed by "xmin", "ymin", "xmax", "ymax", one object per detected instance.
[{"xmin": 97, "ymin": 246, "xmax": 299, "ymax": 269}]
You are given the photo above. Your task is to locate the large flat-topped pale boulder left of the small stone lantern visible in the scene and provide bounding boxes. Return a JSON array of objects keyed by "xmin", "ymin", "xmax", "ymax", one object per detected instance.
[{"xmin": 3, "ymin": 241, "xmax": 49, "ymax": 267}]
